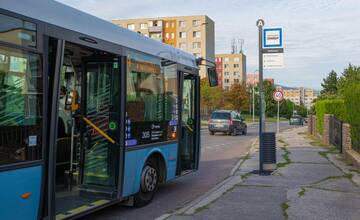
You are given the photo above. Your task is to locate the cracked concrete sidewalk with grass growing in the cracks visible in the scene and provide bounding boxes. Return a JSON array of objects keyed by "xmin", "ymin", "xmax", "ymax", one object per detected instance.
[{"xmin": 164, "ymin": 127, "xmax": 360, "ymax": 220}]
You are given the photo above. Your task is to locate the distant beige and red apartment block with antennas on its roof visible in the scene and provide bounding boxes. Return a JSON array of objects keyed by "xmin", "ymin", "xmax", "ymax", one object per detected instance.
[{"xmin": 215, "ymin": 53, "xmax": 246, "ymax": 90}]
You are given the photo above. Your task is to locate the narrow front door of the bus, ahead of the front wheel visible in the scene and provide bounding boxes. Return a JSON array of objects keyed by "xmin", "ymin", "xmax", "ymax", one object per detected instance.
[{"xmin": 180, "ymin": 74, "xmax": 197, "ymax": 171}]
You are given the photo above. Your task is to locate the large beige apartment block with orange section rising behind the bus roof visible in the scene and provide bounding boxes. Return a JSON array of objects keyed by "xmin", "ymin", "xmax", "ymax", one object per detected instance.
[{"xmin": 112, "ymin": 15, "xmax": 215, "ymax": 78}]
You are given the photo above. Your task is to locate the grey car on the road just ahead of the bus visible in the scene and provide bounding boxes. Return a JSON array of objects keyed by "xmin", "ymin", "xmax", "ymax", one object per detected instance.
[{"xmin": 208, "ymin": 110, "xmax": 247, "ymax": 136}]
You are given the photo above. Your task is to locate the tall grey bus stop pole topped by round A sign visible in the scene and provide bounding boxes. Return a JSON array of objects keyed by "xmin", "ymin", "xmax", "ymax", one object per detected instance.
[{"xmin": 257, "ymin": 19, "xmax": 264, "ymax": 174}]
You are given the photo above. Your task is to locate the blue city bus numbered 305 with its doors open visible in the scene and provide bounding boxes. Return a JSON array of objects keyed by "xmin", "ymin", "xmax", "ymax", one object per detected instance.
[{"xmin": 0, "ymin": 0, "xmax": 216, "ymax": 220}]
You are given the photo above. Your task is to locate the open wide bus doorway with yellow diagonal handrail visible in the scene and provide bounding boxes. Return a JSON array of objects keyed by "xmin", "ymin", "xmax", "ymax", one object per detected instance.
[{"xmin": 55, "ymin": 43, "xmax": 120, "ymax": 219}]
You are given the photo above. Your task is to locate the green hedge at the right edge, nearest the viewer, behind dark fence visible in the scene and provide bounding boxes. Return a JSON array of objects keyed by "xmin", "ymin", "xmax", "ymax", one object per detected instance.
[{"xmin": 344, "ymin": 84, "xmax": 360, "ymax": 152}]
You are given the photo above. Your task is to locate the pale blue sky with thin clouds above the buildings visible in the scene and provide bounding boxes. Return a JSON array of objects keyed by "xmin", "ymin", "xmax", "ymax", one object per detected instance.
[{"xmin": 58, "ymin": 0, "xmax": 360, "ymax": 89}]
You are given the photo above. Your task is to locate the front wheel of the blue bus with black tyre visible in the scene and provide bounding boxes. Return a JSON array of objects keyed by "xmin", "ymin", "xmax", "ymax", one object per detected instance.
[{"xmin": 134, "ymin": 158, "xmax": 160, "ymax": 207}]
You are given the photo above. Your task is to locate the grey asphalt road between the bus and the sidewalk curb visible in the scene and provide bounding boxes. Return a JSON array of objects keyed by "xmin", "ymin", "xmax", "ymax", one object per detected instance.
[{"xmin": 87, "ymin": 122, "xmax": 293, "ymax": 220}]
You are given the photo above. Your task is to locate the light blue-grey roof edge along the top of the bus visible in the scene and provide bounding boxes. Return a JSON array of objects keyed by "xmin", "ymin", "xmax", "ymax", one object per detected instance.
[{"xmin": 0, "ymin": 0, "xmax": 198, "ymax": 68}]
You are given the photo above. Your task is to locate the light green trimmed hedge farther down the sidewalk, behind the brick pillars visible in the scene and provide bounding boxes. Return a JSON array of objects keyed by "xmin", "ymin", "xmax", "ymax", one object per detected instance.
[{"xmin": 315, "ymin": 99, "xmax": 347, "ymax": 134}]
